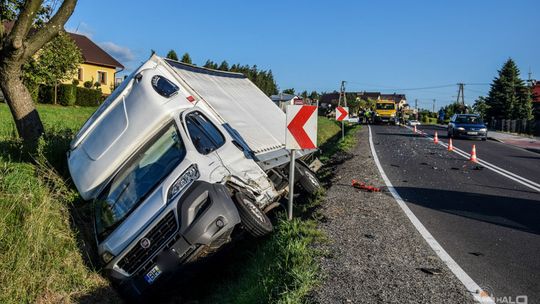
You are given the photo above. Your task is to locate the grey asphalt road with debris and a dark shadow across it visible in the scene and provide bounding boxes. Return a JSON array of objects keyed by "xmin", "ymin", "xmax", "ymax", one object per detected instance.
[{"xmin": 371, "ymin": 126, "xmax": 540, "ymax": 303}]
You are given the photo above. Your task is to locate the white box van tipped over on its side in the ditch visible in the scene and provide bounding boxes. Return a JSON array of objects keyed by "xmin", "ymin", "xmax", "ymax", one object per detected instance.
[{"xmin": 68, "ymin": 55, "xmax": 319, "ymax": 296}]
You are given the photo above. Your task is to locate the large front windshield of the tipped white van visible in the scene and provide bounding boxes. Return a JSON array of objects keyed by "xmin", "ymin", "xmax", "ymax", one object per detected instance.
[{"xmin": 95, "ymin": 124, "xmax": 186, "ymax": 241}]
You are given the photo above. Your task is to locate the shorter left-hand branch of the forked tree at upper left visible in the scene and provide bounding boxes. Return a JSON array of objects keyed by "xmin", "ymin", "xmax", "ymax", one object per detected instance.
[{"xmin": 7, "ymin": 0, "xmax": 43, "ymax": 50}]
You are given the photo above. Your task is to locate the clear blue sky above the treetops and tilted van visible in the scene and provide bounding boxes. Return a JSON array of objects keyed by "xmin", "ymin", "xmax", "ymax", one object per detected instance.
[{"xmin": 66, "ymin": 0, "xmax": 540, "ymax": 108}]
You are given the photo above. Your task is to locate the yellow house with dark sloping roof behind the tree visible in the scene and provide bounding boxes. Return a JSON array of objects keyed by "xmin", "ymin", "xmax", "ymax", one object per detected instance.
[{"xmin": 4, "ymin": 21, "xmax": 124, "ymax": 95}]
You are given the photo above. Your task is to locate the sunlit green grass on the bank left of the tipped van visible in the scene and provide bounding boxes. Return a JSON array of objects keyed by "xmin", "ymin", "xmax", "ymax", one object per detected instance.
[{"xmin": 0, "ymin": 104, "xmax": 118, "ymax": 303}]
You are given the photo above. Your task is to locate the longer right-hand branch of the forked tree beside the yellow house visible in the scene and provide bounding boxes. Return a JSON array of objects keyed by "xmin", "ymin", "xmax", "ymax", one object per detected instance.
[{"xmin": 23, "ymin": 0, "xmax": 77, "ymax": 59}]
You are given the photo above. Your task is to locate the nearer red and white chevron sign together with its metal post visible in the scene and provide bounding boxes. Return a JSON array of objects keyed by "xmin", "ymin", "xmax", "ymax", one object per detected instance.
[{"xmin": 285, "ymin": 105, "xmax": 317, "ymax": 220}]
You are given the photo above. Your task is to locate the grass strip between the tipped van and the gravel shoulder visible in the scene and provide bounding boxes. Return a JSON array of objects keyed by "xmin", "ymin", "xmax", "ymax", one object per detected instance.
[{"xmin": 196, "ymin": 117, "xmax": 359, "ymax": 303}]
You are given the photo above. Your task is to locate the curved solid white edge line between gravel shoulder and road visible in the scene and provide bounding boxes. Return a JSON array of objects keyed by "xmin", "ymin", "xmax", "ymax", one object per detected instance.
[{"xmin": 368, "ymin": 125, "xmax": 495, "ymax": 304}]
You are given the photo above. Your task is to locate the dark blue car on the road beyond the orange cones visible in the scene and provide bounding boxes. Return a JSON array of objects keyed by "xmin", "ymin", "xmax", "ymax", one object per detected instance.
[{"xmin": 448, "ymin": 114, "xmax": 488, "ymax": 140}]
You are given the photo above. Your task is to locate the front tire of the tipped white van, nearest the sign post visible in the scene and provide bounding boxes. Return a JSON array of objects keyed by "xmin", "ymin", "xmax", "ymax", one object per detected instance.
[{"xmin": 234, "ymin": 192, "xmax": 273, "ymax": 237}]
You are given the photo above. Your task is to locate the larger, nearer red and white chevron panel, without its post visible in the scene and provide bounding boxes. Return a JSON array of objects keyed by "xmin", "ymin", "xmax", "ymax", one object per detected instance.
[{"xmin": 285, "ymin": 105, "xmax": 317, "ymax": 149}]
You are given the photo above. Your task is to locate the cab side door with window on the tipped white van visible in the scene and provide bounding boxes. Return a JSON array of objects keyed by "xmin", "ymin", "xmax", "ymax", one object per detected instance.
[{"xmin": 182, "ymin": 110, "xmax": 230, "ymax": 183}]
